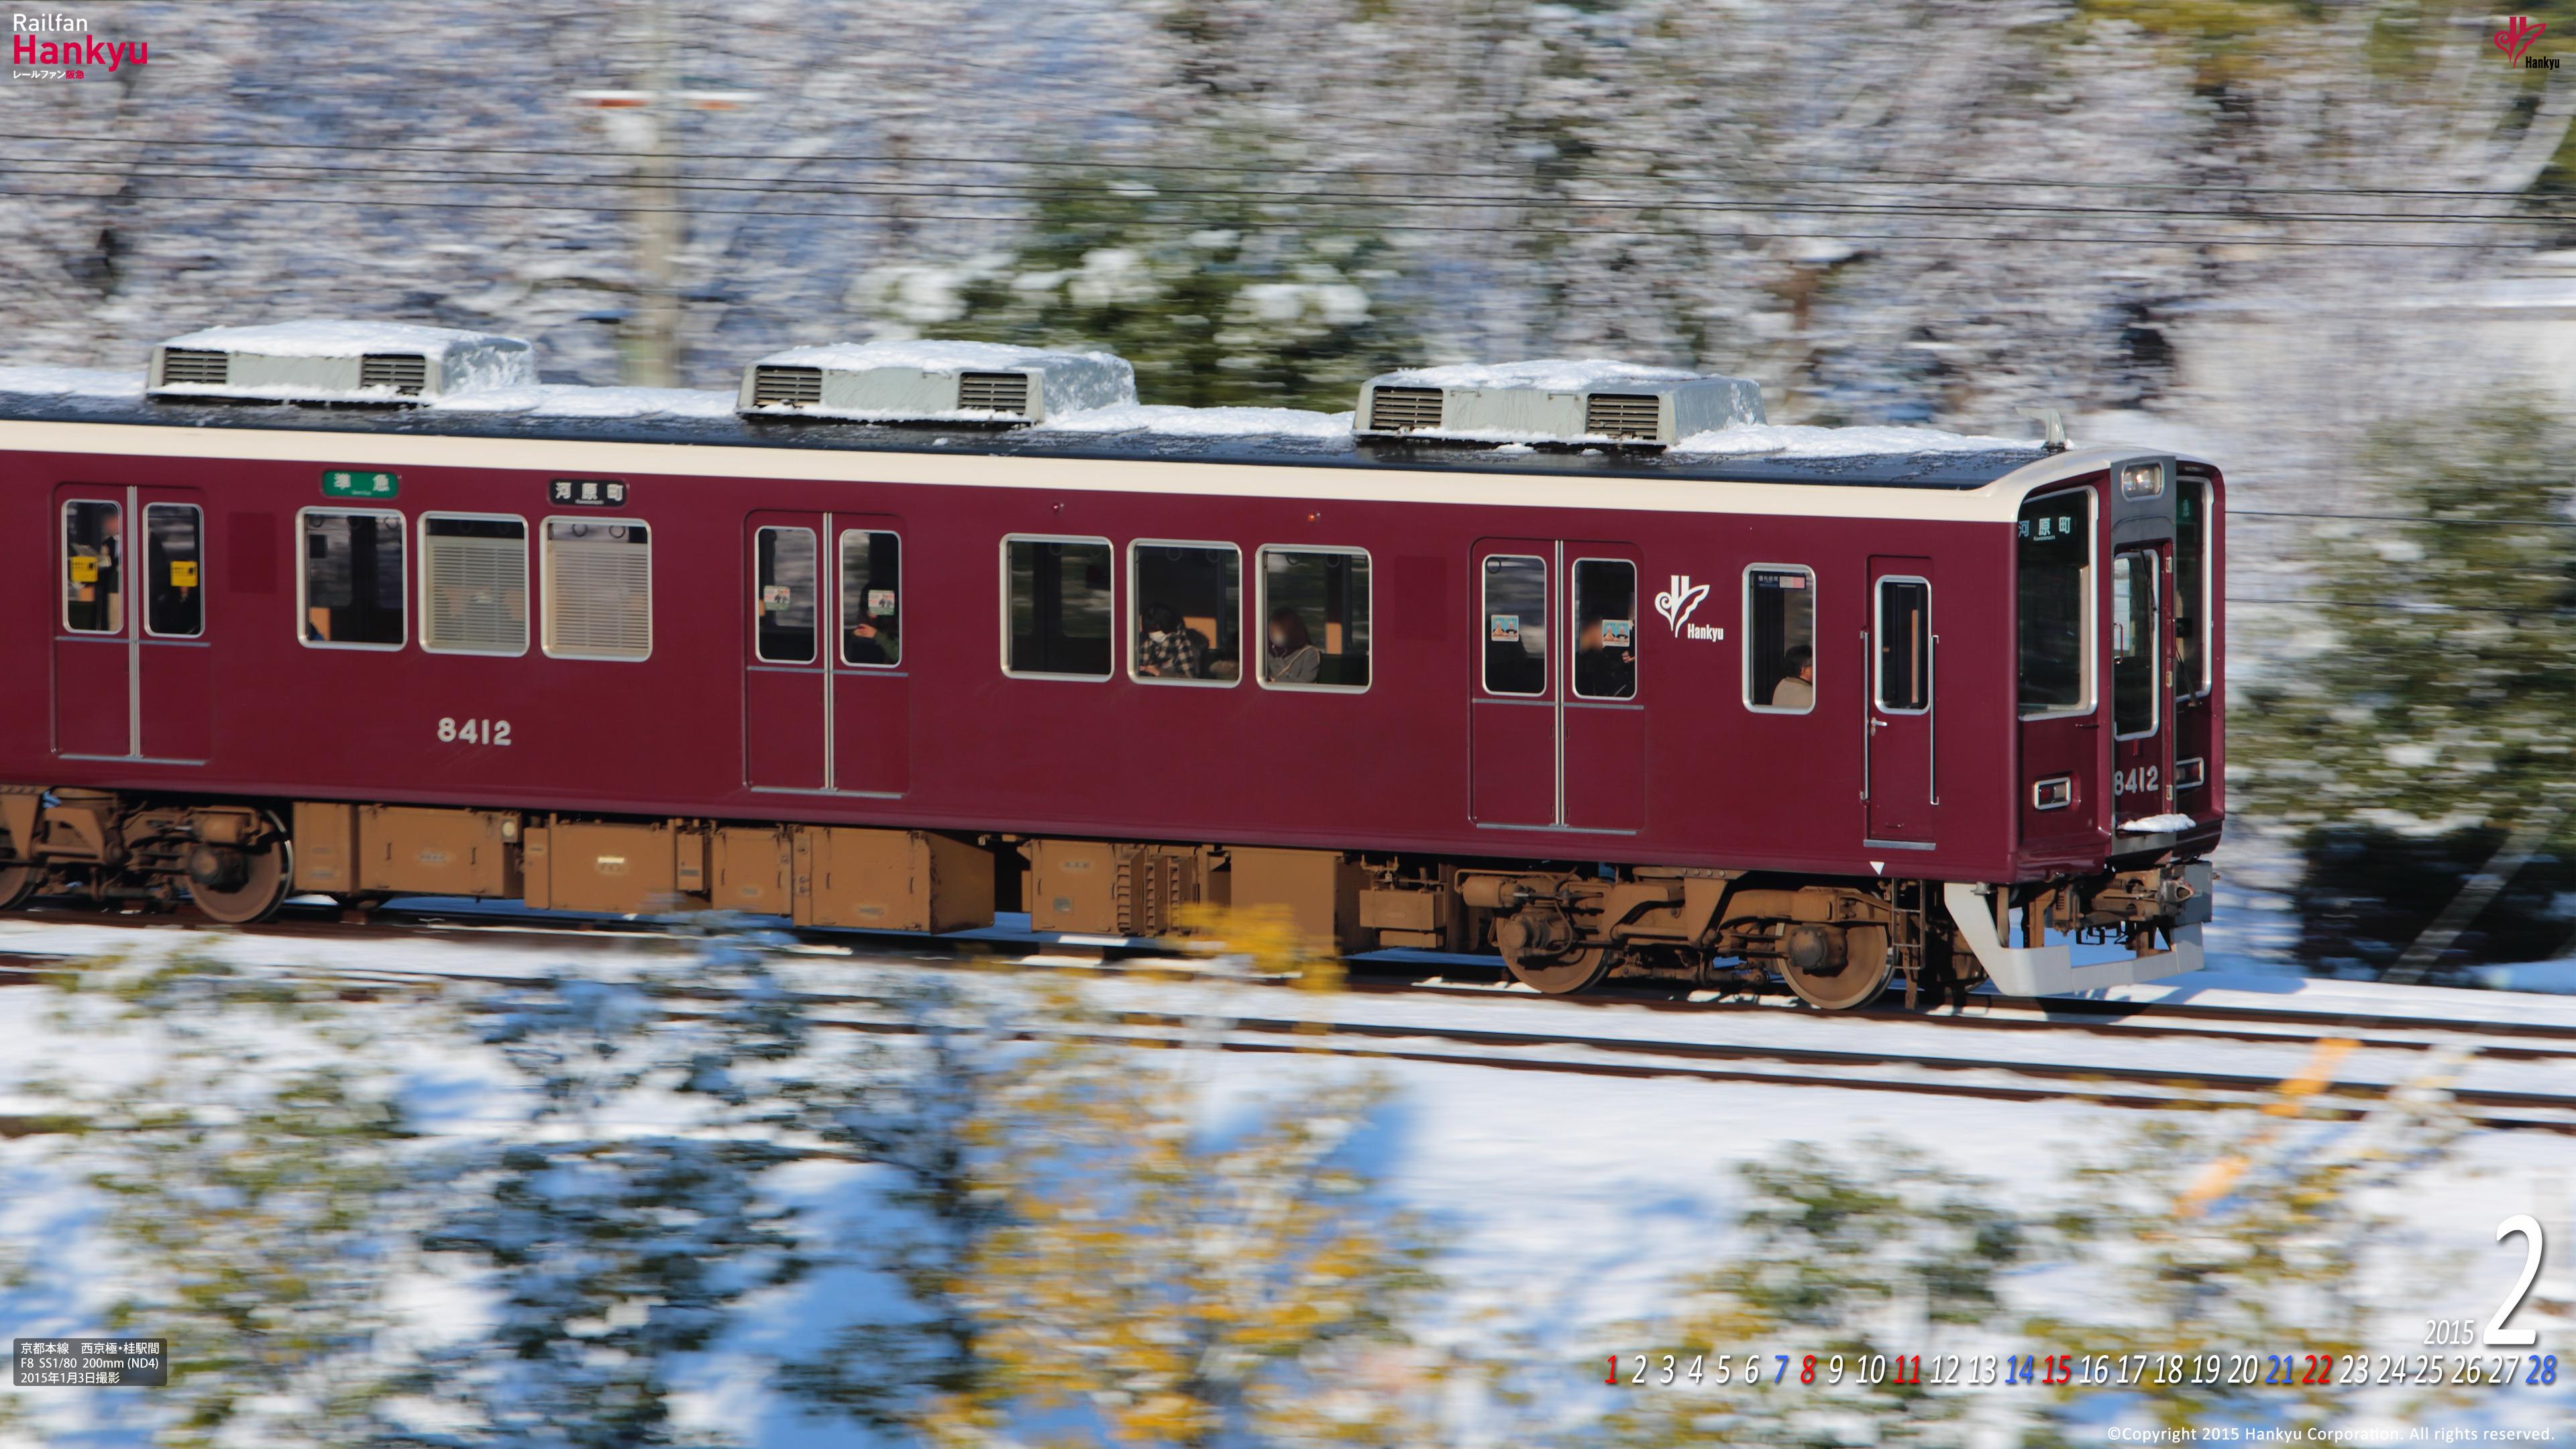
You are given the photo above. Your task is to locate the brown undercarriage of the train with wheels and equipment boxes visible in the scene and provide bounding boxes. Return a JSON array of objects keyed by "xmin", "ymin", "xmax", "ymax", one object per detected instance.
[{"xmin": 0, "ymin": 786, "xmax": 2213, "ymax": 1011}]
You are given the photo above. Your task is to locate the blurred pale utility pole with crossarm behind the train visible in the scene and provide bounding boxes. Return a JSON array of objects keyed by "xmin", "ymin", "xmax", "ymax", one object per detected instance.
[{"xmin": 572, "ymin": 0, "xmax": 757, "ymax": 387}]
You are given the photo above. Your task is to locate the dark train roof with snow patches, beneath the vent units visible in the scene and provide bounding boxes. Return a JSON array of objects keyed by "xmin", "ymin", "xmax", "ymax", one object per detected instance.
[{"xmin": 0, "ymin": 366, "xmax": 2074, "ymax": 490}]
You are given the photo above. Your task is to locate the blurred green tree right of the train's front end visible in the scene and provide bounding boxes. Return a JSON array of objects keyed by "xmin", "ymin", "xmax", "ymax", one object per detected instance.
[{"xmin": 2229, "ymin": 400, "xmax": 2576, "ymax": 969}]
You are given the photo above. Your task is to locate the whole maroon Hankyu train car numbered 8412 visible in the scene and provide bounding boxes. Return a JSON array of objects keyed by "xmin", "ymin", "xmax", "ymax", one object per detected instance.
[{"xmin": 0, "ymin": 371, "xmax": 2226, "ymax": 1008}]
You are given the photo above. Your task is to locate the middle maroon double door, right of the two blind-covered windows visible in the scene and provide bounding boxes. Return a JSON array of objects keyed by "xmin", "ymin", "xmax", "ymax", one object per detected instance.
[{"xmin": 742, "ymin": 513, "xmax": 912, "ymax": 794}]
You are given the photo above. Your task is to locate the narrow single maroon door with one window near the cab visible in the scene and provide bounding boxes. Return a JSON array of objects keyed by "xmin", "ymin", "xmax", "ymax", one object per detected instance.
[{"xmin": 1860, "ymin": 557, "xmax": 1940, "ymax": 851}]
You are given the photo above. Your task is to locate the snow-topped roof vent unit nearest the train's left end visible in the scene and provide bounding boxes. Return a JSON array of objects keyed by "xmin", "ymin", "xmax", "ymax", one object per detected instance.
[{"xmin": 147, "ymin": 322, "xmax": 536, "ymax": 402}]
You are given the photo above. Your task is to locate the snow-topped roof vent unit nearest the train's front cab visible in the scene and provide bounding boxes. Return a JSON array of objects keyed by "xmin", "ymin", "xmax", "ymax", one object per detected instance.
[{"xmin": 1350, "ymin": 358, "xmax": 1762, "ymax": 446}]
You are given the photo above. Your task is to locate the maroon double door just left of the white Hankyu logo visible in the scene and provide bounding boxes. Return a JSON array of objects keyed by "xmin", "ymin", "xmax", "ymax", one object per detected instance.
[{"xmin": 1468, "ymin": 539, "xmax": 1646, "ymax": 830}]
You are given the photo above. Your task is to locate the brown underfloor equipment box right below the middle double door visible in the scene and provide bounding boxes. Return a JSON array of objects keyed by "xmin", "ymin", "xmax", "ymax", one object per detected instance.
[{"xmin": 791, "ymin": 825, "xmax": 991, "ymax": 933}]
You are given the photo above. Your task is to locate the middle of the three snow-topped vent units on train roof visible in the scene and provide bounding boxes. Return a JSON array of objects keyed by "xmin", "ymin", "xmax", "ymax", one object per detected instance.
[{"xmin": 737, "ymin": 340, "xmax": 1136, "ymax": 423}]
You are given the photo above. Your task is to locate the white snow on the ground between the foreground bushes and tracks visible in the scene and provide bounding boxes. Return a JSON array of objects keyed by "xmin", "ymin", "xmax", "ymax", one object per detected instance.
[{"xmin": 0, "ymin": 920, "xmax": 2576, "ymax": 1449}]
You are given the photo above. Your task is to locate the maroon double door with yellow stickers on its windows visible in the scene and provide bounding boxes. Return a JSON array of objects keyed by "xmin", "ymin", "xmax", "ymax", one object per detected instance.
[{"xmin": 54, "ymin": 485, "xmax": 211, "ymax": 763}]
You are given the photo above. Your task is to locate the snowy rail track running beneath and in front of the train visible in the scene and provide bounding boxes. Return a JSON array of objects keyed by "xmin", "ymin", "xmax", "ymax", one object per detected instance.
[{"xmin": 0, "ymin": 908, "xmax": 2576, "ymax": 1134}]
